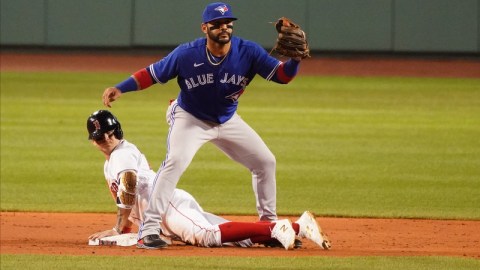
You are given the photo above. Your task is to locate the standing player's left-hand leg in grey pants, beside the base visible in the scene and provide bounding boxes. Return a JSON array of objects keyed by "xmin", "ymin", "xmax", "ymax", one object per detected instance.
[{"xmin": 139, "ymin": 104, "xmax": 214, "ymax": 238}]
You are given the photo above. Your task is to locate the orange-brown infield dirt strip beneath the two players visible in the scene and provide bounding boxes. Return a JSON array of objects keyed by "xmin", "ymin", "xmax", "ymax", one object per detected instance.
[{"xmin": 1, "ymin": 212, "xmax": 480, "ymax": 258}]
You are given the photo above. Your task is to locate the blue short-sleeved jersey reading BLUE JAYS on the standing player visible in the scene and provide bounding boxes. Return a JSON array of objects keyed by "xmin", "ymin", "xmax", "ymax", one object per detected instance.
[{"xmin": 147, "ymin": 36, "xmax": 282, "ymax": 124}]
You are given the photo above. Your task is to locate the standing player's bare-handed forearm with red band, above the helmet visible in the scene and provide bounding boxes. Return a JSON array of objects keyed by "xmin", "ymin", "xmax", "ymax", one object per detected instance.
[{"xmin": 102, "ymin": 68, "xmax": 155, "ymax": 107}]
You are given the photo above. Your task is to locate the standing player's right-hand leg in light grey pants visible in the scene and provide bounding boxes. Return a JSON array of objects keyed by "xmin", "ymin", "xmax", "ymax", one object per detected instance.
[{"xmin": 212, "ymin": 114, "xmax": 277, "ymax": 221}]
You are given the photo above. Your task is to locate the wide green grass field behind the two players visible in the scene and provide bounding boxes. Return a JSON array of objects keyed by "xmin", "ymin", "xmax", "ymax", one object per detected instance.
[{"xmin": 1, "ymin": 72, "xmax": 480, "ymax": 219}]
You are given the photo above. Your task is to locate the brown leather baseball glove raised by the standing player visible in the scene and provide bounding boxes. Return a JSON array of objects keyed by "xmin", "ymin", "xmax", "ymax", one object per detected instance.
[{"xmin": 272, "ymin": 17, "xmax": 310, "ymax": 59}]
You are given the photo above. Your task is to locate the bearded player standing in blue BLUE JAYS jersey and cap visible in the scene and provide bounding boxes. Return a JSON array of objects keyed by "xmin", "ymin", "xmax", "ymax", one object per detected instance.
[{"xmin": 102, "ymin": 2, "xmax": 308, "ymax": 248}]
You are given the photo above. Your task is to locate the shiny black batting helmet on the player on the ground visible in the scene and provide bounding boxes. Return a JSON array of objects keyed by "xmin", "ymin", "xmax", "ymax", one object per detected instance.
[{"xmin": 87, "ymin": 110, "xmax": 123, "ymax": 140}]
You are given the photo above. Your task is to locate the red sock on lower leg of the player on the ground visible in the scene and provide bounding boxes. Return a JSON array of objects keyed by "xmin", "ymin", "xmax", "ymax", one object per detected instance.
[{"xmin": 218, "ymin": 222, "xmax": 275, "ymax": 243}]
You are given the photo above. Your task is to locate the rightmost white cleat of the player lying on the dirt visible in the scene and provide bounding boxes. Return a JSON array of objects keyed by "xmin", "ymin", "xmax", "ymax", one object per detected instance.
[{"xmin": 295, "ymin": 211, "xmax": 332, "ymax": 250}]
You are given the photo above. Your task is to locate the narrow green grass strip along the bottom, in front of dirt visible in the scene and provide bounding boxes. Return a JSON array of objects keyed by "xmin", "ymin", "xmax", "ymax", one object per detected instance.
[{"xmin": 1, "ymin": 254, "xmax": 480, "ymax": 270}]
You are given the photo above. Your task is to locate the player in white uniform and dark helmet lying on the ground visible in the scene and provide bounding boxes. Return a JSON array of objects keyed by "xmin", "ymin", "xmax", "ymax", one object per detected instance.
[{"xmin": 87, "ymin": 110, "xmax": 329, "ymax": 249}]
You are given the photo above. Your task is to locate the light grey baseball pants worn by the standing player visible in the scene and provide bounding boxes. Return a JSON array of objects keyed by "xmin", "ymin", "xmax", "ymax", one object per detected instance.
[{"xmin": 139, "ymin": 101, "xmax": 277, "ymax": 238}]
